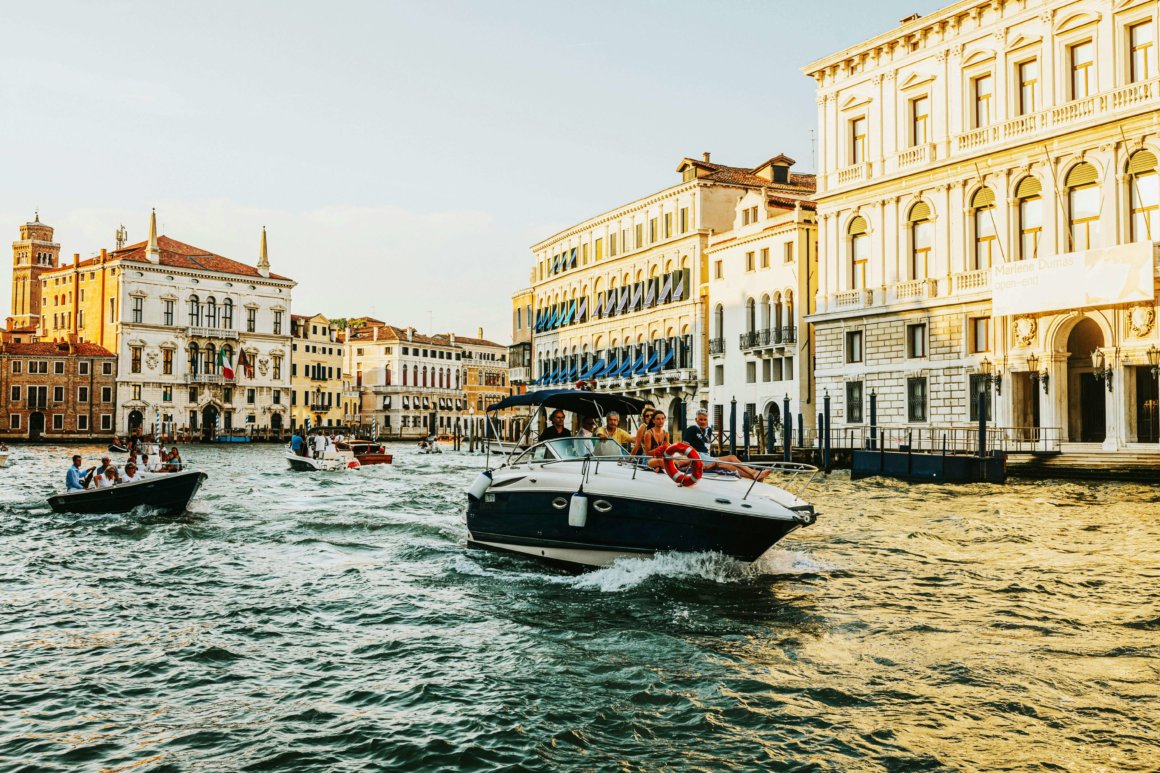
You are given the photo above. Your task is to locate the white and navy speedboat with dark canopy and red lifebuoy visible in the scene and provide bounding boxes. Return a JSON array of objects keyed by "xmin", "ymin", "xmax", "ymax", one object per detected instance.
[{"xmin": 466, "ymin": 390, "xmax": 818, "ymax": 566}]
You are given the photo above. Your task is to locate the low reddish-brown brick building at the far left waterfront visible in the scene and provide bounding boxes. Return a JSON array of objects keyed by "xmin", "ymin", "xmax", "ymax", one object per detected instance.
[{"xmin": 0, "ymin": 341, "xmax": 117, "ymax": 441}]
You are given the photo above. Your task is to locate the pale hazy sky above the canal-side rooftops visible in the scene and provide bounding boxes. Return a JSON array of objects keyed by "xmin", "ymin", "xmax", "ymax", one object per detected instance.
[{"xmin": 0, "ymin": 0, "xmax": 944, "ymax": 342}]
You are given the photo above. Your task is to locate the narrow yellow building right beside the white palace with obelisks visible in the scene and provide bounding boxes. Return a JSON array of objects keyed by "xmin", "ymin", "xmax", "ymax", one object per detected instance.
[{"xmin": 290, "ymin": 315, "xmax": 358, "ymax": 429}]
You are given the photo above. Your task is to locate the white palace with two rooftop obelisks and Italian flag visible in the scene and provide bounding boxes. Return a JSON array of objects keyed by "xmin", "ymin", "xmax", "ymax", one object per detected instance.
[{"xmin": 41, "ymin": 215, "xmax": 295, "ymax": 436}]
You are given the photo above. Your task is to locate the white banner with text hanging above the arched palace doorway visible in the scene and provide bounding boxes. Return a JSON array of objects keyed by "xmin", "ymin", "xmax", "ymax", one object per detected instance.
[{"xmin": 991, "ymin": 241, "xmax": 1155, "ymax": 317}]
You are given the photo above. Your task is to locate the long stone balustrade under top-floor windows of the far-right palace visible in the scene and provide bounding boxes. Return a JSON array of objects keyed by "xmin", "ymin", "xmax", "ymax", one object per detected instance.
[{"xmin": 951, "ymin": 78, "xmax": 1160, "ymax": 157}]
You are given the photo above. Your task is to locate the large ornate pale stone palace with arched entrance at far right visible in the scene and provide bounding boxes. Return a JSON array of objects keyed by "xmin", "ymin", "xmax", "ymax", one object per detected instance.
[{"xmin": 806, "ymin": 0, "xmax": 1160, "ymax": 449}]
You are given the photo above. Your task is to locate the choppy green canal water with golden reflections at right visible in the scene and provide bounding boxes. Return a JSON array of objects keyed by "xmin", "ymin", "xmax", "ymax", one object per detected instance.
[{"xmin": 0, "ymin": 447, "xmax": 1160, "ymax": 771}]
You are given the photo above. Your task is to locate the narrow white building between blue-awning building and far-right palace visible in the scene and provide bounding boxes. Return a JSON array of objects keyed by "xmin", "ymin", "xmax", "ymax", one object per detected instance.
[{"xmin": 705, "ymin": 156, "xmax": 818, "ymax": 445}]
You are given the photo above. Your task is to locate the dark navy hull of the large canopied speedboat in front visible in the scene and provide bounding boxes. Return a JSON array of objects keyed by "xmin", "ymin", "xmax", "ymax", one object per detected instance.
[{"xmin": 467, "ymin": 490, "xmax": 806, "ymax": 566}]
